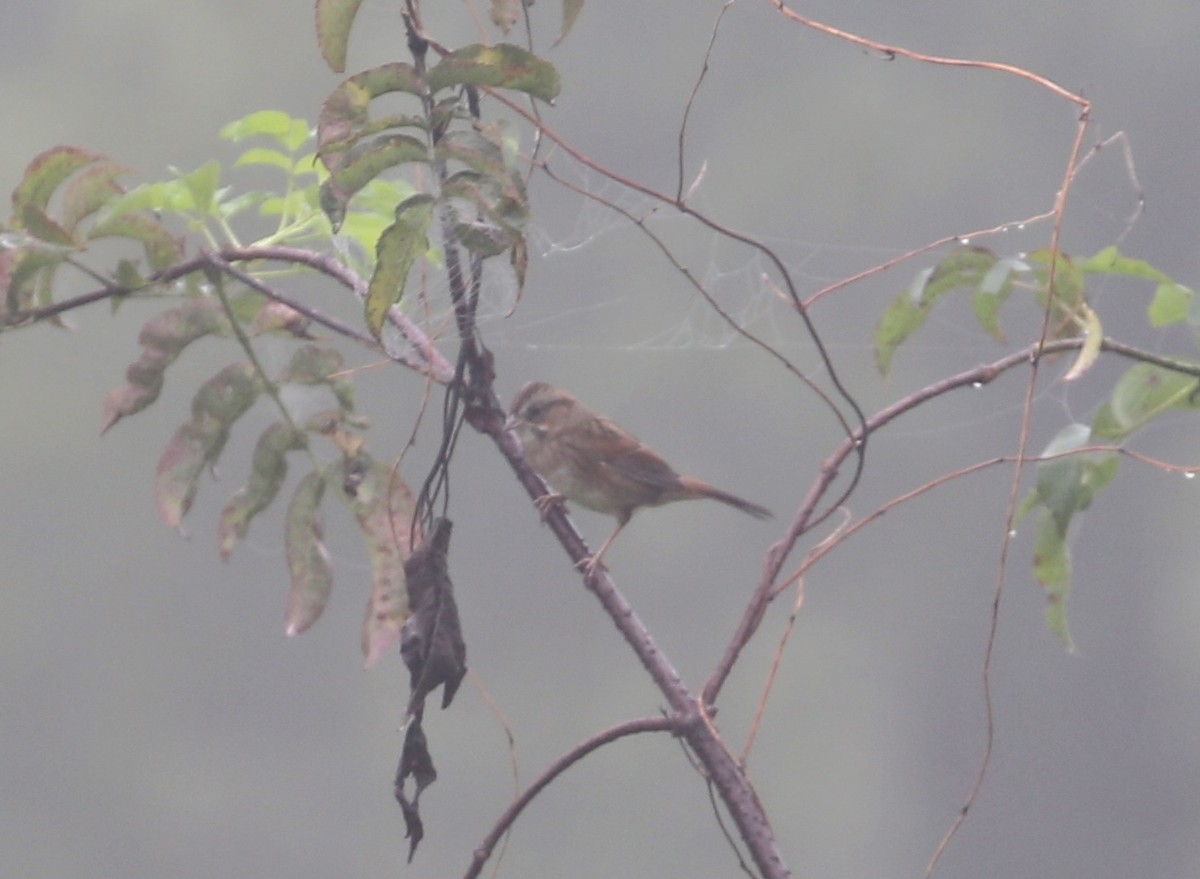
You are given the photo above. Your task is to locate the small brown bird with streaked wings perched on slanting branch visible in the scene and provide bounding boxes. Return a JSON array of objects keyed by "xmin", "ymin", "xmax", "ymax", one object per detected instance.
[{"xmin": 504, "ymin": 382, "xmax": 773, "ymax": 576}]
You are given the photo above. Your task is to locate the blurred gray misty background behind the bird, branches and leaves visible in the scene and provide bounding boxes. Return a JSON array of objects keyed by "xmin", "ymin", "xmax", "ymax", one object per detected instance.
[{"xmin": 0, "ymin": 0, "xmax": 1200, "ymax": 879}]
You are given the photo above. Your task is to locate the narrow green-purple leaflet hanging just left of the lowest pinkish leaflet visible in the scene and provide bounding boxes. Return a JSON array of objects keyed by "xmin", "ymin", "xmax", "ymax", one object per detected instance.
[{"xmin": 283, "ymin": 471, "xmax": 334, "ymax": 635}]
